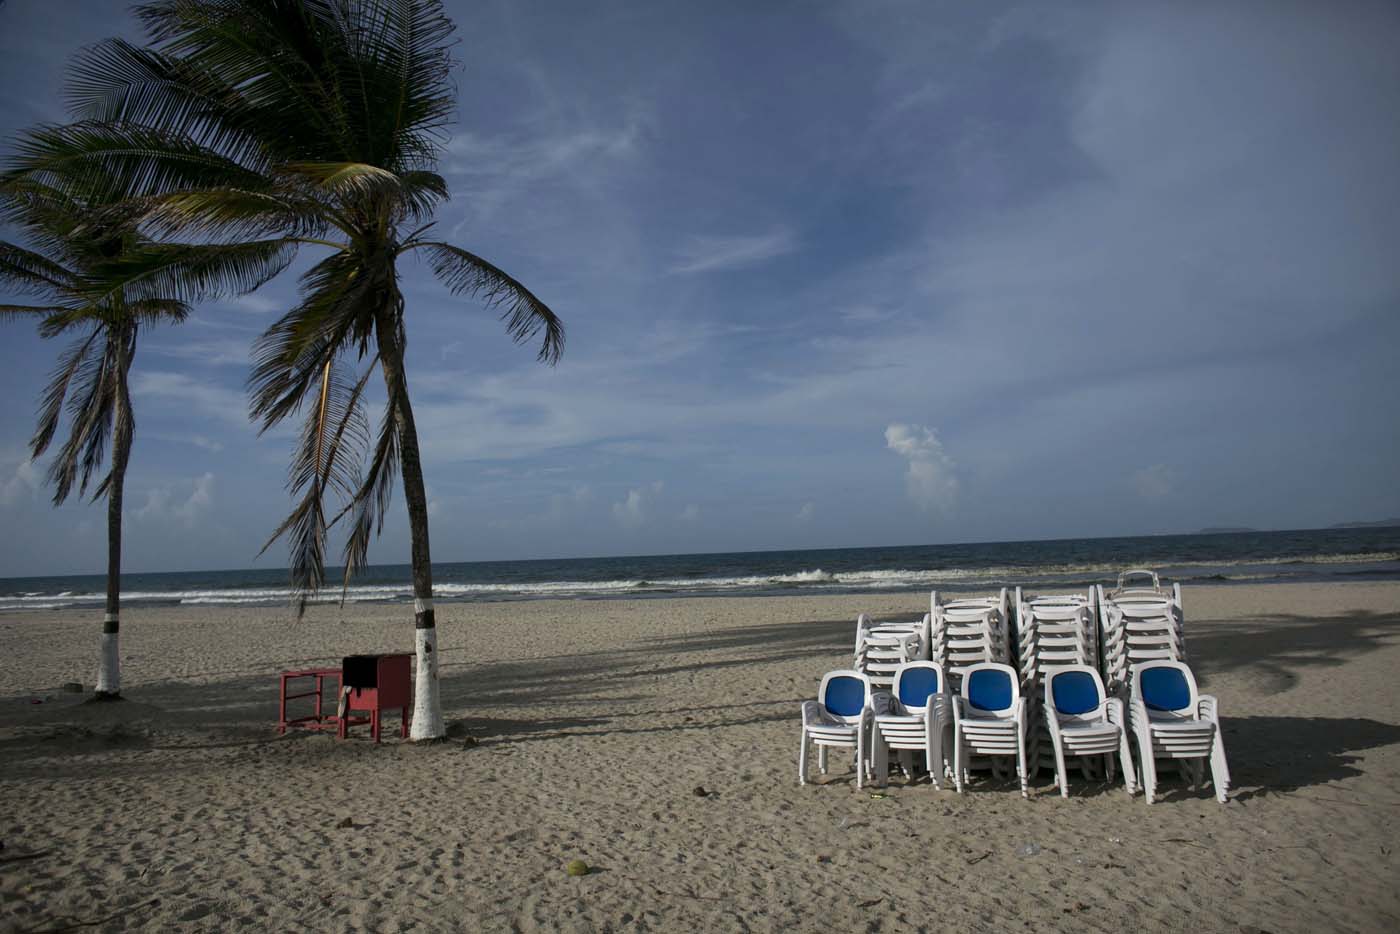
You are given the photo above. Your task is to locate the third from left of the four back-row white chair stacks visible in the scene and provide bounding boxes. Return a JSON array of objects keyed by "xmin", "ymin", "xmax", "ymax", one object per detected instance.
[{"xmin": 1016, "ymin": 587, "xmax": 1099, "ymax": 777}]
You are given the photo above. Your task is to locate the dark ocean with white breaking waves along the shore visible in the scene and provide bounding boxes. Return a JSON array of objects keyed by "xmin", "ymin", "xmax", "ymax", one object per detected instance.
[{"xmin": 0, "ymin": 528, "xmax": 1400, "ymax": 612}]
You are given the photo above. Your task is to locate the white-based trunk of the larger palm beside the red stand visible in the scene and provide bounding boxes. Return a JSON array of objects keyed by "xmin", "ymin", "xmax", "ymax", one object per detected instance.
[{"xmin": 375, "ymin": 295, "xmax": 447, "ymax": 742}]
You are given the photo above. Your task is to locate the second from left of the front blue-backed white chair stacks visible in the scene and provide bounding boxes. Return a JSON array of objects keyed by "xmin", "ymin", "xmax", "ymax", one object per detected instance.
[{"xmin": 871, "ymin": 661, "xmax": 953, "ymax": 788}]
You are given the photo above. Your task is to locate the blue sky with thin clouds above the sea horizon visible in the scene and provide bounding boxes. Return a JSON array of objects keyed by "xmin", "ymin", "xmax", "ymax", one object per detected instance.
[{"xmin": 0, "ymin": 0, "xmax": 1400, "ymax": 576}]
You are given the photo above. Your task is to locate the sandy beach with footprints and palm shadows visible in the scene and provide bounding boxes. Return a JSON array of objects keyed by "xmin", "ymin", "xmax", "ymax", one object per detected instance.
[{"xmin": 0, "ymin": 583, "xmax": 1400, "ymax": 934}]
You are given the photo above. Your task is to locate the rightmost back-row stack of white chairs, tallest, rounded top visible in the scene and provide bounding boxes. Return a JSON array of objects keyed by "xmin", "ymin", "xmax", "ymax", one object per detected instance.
[{"xmin": 1099, "ymin": 570, "xmax": 1186, "ymax": 690}]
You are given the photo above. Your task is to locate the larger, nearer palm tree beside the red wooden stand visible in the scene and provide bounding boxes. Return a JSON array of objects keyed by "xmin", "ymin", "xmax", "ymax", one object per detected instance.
[{"xmin": 6, "ymin": 0, "xmax": 564, "ymax": 739}]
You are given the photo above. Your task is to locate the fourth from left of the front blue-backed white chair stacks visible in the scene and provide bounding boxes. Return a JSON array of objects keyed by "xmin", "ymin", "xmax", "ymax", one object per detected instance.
[{"xmin": 1044, "ymin": 665, "xmax": 1137, "ymax": 798}]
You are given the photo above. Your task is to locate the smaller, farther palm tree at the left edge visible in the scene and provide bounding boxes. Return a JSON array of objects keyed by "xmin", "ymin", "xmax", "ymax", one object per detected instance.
[{"xmin": 0, "ymin": 180, "xmax": 290, "ymax": 699}]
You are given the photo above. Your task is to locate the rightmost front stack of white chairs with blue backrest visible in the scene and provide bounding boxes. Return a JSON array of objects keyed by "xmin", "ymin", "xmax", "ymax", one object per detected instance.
[{"xmin": 1128, "ymin": 661, "xmax": 1229, "ymax": 804}]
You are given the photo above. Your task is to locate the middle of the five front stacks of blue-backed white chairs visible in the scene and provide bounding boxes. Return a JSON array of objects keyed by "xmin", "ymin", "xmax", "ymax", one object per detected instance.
[{"xmin": 952, "ymin": 662, "xmax": 1030, "ymax": 798}]
